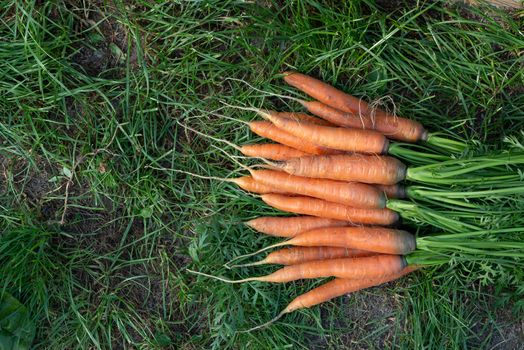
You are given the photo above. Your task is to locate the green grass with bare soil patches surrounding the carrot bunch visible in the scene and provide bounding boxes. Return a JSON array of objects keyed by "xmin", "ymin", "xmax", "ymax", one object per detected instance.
[{"xmin": 0, "ymin": 0, "xmax": 524, "ymax": 349}]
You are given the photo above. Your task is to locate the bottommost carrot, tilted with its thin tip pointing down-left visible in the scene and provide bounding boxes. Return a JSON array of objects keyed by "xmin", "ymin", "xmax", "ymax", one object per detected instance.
[{"xmin": 247, "ymin": 265, "xmax": 420, "ymax": 332}]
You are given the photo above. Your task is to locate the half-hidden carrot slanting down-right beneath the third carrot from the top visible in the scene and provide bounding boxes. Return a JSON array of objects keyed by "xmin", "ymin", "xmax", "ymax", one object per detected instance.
[{"xmin": 249, "ymin": 121, "xmax": 341, "ymax": 154}]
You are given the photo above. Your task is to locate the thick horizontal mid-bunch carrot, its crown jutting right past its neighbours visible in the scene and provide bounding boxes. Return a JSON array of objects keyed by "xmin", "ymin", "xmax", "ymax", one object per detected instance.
[{"xmin": 272, "ymin": 154, "xmax": 406, "ymax": 185}]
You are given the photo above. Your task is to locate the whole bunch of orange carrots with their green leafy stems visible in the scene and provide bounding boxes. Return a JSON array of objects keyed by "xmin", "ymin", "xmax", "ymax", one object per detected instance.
[{"xmin": 188, "ymin": 72, "xmax": 524, "ymax": 328}]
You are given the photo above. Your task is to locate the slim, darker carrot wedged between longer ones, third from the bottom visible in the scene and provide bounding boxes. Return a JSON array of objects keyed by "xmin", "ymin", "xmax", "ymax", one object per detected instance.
[{"xmin": 231, "ymin": 247, "xmax": 376, "ymax": 267}]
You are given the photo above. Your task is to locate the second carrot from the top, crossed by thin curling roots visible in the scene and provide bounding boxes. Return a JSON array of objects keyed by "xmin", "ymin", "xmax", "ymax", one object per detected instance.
[{"xmin": 300, "ymin": 100, "xmax": 428, "ymax": 142}]
